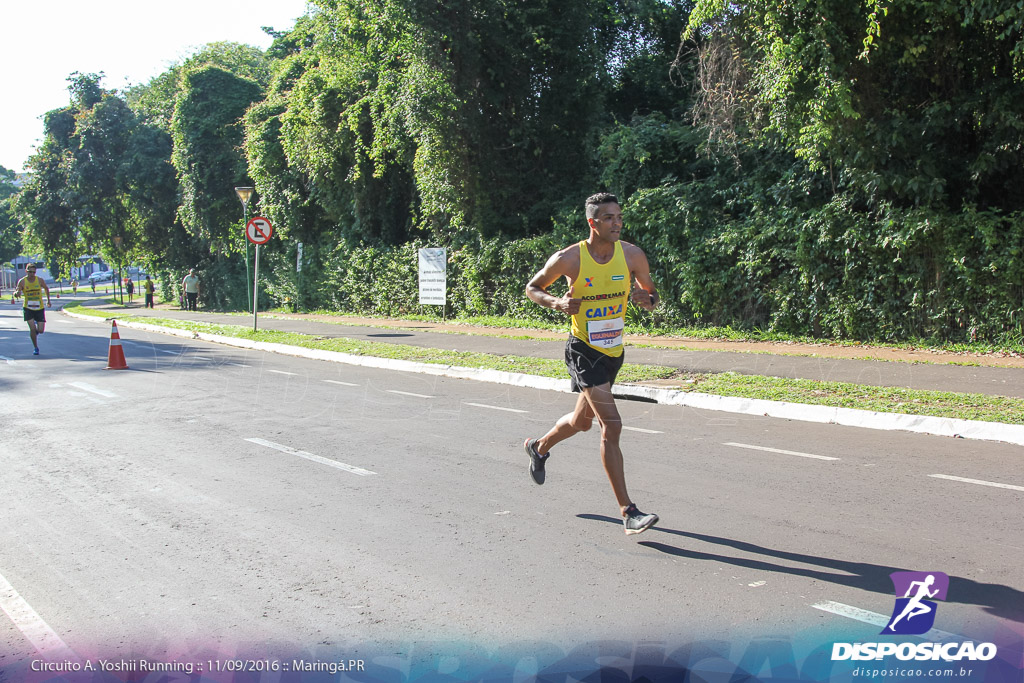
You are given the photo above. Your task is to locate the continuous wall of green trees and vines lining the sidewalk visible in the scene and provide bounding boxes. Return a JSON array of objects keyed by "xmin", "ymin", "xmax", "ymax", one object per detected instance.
[{"xmin": 14, "ymin": 0, "xmax": 1024, "ymax": 348}]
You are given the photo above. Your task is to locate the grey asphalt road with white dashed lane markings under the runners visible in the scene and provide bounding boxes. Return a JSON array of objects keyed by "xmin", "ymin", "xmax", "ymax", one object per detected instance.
[{"xmin": 0, "ymin": 307, "xmax": 1024, "ymax": 676}]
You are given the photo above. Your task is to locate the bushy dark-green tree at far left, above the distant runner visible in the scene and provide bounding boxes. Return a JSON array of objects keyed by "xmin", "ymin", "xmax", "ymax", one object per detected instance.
[{"xmin": 16, "ymin": 74, "xmax": 176, "ymax": 282}]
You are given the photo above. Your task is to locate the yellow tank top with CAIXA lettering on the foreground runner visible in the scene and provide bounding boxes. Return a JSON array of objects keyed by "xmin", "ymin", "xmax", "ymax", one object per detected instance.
[{"xmin": 572, "ymin": 240, "xmax": 630, "ymax": 357}]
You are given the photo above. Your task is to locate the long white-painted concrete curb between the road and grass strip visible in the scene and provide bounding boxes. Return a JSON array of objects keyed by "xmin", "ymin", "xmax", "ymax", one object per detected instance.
[{"xmin": 70, "ymin": 311, "xmax": 1024, "ymax": 445}]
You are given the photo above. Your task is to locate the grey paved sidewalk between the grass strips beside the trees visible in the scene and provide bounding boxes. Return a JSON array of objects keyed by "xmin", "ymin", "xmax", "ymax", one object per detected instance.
[{"xmin": 72, "ymin": 301, "xmax": 1024, "ymax": 398}]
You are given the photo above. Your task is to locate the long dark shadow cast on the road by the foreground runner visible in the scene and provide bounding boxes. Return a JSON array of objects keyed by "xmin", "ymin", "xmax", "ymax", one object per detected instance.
[{"xmin": 577, "ymin": 514, "xmax": 1024, "ymax": 623}]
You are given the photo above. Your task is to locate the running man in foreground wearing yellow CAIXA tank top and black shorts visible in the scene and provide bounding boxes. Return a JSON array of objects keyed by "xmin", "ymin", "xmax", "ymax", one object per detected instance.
[{"xmin": 524, "ymin": 193, "xmax": 658, "ymax": 533}]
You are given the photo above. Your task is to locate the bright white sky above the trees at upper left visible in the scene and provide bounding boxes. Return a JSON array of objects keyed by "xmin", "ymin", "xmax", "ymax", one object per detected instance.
[{"xmin": 0, "ymin": 0, "xmax": 306, "ymax": 173}]
